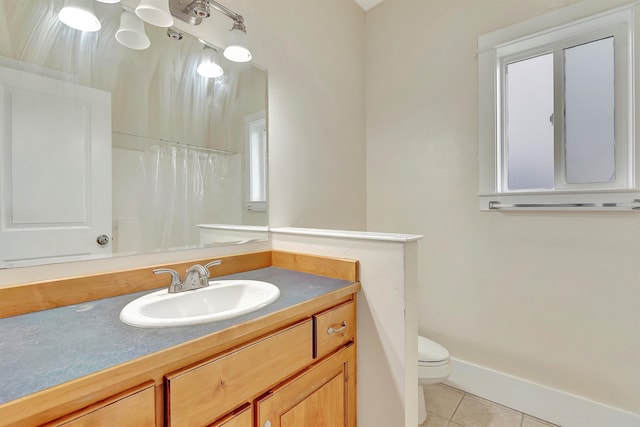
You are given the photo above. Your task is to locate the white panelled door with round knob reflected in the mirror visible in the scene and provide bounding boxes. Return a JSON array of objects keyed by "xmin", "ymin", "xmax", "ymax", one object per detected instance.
[{"xmin": 0, "ymin": 67, "xmax": 111, "ymax": 268}]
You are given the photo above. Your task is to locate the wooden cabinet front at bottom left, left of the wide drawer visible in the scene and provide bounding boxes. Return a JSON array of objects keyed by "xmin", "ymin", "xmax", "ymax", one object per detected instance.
[{"xmin": 46, "ymin": 383, "xmax": 156, "ymax": 427}]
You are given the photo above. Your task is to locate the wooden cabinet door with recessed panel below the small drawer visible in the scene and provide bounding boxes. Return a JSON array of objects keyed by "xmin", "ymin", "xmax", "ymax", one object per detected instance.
[{"xmin": 256, "ymin": 344, "xmax": 356, "ymax": 427}]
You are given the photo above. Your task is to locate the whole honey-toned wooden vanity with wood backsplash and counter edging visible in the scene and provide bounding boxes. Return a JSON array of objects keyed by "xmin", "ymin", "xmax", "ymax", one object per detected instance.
[{"xmin": 0, "ymin": 251, "xmax": 361, "ymax": 427}]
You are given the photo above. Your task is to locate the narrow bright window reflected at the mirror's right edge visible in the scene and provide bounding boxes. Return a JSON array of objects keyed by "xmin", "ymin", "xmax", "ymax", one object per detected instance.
[{"xmin": 245, "ymin": 112, "xmax": 267, "ymax": 211}]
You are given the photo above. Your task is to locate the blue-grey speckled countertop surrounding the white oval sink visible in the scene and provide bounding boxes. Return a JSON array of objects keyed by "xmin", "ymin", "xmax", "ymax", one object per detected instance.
[{"xmin": 0, "ymin": 267, "xmax": 352, "ymax": 404}]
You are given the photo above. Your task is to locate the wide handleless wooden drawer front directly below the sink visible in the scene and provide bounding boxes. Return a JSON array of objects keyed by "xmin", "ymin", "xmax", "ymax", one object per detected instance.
[{"xmin": 165, "ymin": 319, "xmax": 313, "ymax": 427}]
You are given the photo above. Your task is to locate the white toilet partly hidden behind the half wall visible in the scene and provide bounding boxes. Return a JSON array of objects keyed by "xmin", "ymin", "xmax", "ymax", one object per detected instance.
[{"xmin": 418, "ymin": 335, "xmax": 451, "ymax": 425}]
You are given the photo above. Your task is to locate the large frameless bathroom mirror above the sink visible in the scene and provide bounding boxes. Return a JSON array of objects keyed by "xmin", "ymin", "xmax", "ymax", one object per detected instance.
[{"xmin": 0, "ymin": 0, "xmax": 268, "ymax": 268}]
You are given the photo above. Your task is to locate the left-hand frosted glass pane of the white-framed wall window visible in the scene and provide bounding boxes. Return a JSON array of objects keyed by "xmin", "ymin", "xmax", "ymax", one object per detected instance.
[{"xmin": 505, "ymin": 53, "xmax": 554, "ymax": 190}]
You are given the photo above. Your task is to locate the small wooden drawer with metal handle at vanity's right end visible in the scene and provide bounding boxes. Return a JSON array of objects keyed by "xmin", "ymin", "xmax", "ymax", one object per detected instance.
[{"xmin": 313, "ymin": 301, "xmax": 356, "ymax": 358}]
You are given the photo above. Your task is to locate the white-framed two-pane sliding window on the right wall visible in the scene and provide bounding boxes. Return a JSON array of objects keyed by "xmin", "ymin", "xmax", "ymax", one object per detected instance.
[{"xmin": 478, "ymin": 2, "xmax": 640, "ymax": 210}]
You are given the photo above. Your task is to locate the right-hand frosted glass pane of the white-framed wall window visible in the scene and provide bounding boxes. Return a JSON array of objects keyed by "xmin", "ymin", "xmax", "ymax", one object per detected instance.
[{"xmin": 564, "ymin": 37, "xmax": 615, "ymax": 184}]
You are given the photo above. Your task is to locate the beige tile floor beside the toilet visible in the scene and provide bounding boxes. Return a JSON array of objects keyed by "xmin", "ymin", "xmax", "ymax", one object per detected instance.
[{"xmin": 420, "ymin": 384, "xmax": 557, "ymax": 427}]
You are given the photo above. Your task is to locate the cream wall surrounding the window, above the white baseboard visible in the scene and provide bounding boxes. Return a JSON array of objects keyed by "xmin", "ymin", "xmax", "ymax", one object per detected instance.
[{"xmin": 366, "ymin": 0, "xmax": 640, "ymax": 413}]
